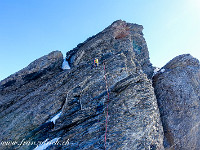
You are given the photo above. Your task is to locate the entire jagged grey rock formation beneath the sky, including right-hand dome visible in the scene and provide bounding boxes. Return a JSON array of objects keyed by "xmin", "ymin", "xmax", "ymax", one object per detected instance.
[{"xmin": 0, "ymin": 20, "xmax": 200, "ymax": 150}]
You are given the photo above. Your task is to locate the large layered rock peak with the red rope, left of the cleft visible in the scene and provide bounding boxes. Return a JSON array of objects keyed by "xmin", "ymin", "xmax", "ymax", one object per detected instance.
[{"xmin": 0, "ymin": 20, "xmax": 163, "ymax": 150}]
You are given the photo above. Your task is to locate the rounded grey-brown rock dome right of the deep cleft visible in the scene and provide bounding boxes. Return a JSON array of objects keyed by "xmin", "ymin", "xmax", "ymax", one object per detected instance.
[{"xmin": 153, "ymin": 54, "xmax": 200, "ymax": 150}]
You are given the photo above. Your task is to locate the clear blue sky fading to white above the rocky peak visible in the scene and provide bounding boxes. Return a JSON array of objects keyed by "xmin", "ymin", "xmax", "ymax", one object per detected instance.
[{"xmin": 0, "ymin": 0, "xmax": 200, "ymax": 80}]
